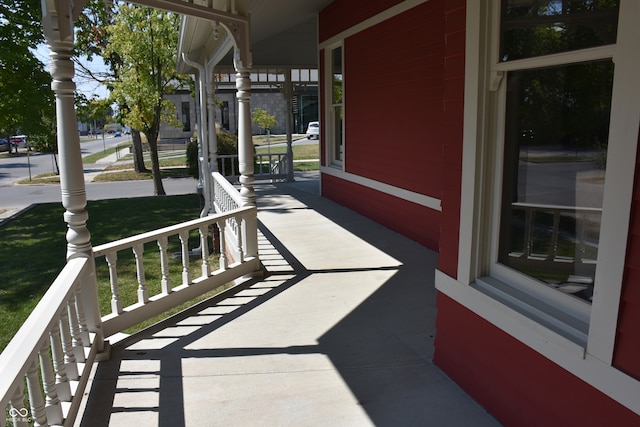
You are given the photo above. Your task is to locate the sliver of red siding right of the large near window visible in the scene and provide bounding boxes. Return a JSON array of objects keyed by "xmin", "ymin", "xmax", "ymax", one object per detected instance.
[{"xmin": 613, "ymin": 129, "xmax": 640, "ymax": 379}]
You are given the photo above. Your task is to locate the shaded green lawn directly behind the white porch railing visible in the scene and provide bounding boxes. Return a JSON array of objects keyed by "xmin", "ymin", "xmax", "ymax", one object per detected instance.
[{"xmin": 0, "ymin": 195, "xmax": 228, "ymax": 351}]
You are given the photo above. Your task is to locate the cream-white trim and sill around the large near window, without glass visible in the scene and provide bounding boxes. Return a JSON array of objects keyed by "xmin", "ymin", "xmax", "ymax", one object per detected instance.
[{"xmin": 436, "ymin": 0, "xmax": 640, "ymax": 414}]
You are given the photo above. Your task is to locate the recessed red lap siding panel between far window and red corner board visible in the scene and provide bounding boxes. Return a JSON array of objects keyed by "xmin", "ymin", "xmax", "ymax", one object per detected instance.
[{"xmin": 344, "ymin": 1, "xmax": 444, "ymax": 198}]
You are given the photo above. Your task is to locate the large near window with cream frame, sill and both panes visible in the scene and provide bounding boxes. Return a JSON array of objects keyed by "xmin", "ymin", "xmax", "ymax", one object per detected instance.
[{"xmin": 436, "ymin": 0, "xmax": 640, "ymax": 411}]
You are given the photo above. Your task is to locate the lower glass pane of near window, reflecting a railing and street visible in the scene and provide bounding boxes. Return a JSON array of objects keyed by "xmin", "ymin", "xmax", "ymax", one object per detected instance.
[{"xmin": 498, "ymin": 60, "xmax": 613, "ymax": 300}]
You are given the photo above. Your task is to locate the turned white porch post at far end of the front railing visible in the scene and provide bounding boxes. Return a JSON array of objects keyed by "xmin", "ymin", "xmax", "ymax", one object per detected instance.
[{"xmin": 234, "ymin": 53, "xmax": 258, "ymax": 268}]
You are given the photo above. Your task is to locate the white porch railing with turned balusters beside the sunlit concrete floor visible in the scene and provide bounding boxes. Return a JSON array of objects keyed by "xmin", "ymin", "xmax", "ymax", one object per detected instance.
[{"xmin": 0, "ymin": 174, "xmax": 260, "ymax": 427}]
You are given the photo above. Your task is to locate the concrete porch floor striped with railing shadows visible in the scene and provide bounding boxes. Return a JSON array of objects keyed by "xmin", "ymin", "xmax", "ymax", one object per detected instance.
[{"xmin": 76, "ymin": 173, "xmax": 499, "ymax": 427}]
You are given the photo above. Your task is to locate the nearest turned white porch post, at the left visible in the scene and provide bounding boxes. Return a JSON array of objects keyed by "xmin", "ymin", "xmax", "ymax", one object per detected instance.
[{"xmin": 42, "ymin": 0, "xmax": 104, "ymax": 351}]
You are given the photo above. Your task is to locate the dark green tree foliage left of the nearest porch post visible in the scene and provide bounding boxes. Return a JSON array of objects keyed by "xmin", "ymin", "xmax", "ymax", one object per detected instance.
[{"xmin": 0, "ymin": 0, "xmax": 54, "ymax": 151}]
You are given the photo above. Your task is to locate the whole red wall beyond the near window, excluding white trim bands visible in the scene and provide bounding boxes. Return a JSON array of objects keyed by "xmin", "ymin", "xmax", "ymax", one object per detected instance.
[{"xmin": 319, "ymin": 0, "xmax": 465, "ymax": 254}]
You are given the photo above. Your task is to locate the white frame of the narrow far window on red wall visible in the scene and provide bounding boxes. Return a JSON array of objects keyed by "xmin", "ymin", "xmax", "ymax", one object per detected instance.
[{"xmin": 321, "ymin": 41, "xmax": 346, "ymax": 172}]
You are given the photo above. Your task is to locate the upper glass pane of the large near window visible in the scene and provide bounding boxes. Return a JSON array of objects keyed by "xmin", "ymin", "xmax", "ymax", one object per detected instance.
[{"xmin": 500, "ymin": 0, "xmax": 619, "ymax": 61}]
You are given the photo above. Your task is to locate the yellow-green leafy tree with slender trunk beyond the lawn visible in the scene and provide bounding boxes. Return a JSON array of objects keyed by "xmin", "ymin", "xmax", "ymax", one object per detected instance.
[{"xmin": 105, "ymin": 5, "xmax": 181, "ymax": 195}]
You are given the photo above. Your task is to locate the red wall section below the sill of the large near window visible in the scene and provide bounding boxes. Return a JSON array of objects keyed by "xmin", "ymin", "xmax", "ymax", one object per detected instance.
[{"xmin": 434, "ymin": 294, "xmax": 640, "ymax": 427}]
